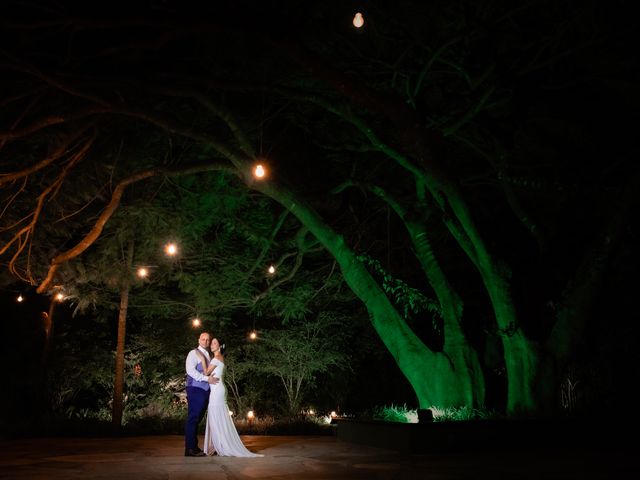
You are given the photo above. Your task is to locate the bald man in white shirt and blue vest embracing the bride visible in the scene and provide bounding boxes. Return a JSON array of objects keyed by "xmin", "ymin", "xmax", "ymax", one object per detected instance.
[{"xmin": 184, "ymin": 332, "xmax": 219, "ymax": 457}]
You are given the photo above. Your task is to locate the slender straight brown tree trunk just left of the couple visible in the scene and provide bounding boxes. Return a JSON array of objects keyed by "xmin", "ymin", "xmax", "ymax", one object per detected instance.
[{"xmin": 111, "ymin": 241, "xmax": 133, "ymax": 428}]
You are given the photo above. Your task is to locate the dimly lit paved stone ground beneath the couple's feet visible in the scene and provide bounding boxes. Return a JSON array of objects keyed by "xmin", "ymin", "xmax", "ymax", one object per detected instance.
[{"xmin": 0, "ymin": 435, "xmax": 638, "ymax": 480}]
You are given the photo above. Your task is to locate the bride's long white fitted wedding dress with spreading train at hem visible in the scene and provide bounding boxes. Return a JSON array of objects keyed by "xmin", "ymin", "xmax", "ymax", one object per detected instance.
[{"xmin": 204, "ymin": 358, "xmax": 264, "ymax": 457}]
